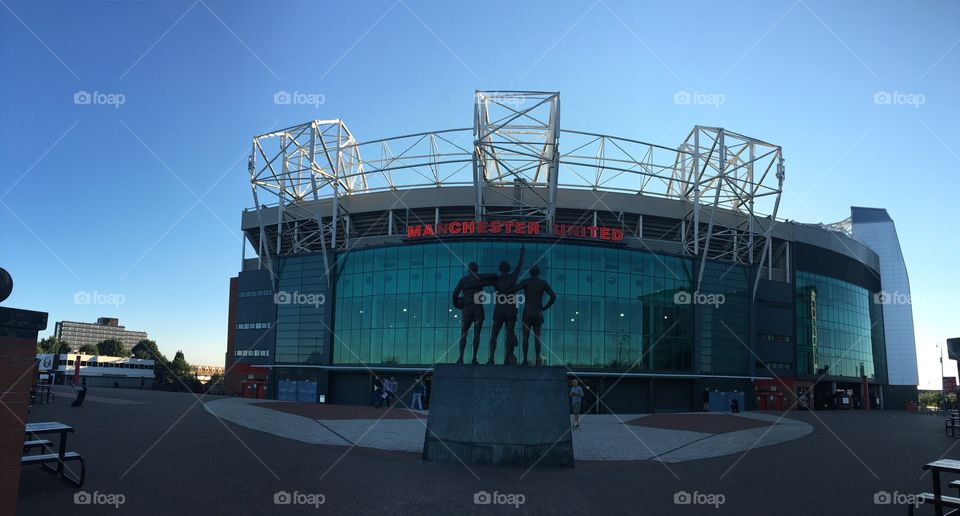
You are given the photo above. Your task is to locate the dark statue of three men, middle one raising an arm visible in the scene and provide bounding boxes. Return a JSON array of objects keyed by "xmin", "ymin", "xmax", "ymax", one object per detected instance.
[{"xmin": 453, "ymin": 245, "xmax": 557, "ymax": 366}]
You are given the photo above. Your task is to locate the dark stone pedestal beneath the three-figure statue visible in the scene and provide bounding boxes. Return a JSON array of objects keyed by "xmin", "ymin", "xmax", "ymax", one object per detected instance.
[{"xmin": 423, "ymin": 364, "xmax": 573, "ymax": 467}]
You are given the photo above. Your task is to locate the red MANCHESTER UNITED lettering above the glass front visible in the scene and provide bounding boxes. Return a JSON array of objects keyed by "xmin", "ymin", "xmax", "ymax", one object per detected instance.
[{"xmin": 407, "ymin": 220, "xmax": 623, "ymax": 242}]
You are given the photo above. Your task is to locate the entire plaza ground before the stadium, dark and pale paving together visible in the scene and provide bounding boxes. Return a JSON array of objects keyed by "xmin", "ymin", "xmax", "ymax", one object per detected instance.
[{"xmin": 18, "ymin": 388, "xmax": 960, "ymax": 515}]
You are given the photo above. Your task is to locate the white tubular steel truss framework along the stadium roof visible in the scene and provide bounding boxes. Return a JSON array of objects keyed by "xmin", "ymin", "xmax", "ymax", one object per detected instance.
[{"xmin": 246, "ymin": 91, "xmax": 784, "ymax": 294}]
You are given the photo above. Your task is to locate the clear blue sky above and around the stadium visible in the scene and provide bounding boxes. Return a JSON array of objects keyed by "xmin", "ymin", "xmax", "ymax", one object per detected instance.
[{"xmin": 0, "ymin": 0, "xmax": 960, "ymax": 387}]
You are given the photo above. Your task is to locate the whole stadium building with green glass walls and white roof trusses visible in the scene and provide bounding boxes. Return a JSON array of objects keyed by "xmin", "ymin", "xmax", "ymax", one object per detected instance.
[{"xmin": 226, "ymin": 91, "xmax": 916, "ymax": 412}]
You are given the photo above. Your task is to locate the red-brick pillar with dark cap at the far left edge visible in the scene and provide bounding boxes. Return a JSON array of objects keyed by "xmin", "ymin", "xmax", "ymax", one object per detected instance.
[{"xmin": 0, "ymin": 307, "xmax": 47, "ymax": 514}]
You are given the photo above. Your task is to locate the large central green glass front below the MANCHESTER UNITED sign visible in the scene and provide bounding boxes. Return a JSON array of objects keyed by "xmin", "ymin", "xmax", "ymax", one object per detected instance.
[{"xmin": 330, "ymin": 241, "xmax": 693, "ymax": 371}]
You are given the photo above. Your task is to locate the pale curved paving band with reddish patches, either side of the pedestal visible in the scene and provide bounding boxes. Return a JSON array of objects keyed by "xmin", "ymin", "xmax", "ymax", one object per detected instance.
[{"xmin": 204, "ymin": 398, "xmax": 813, "ymax": 462}]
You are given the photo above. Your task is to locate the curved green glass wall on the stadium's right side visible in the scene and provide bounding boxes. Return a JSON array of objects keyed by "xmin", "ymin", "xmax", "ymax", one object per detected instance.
[{"xmin": 796, "ymin": 271, "xmax": 886, "ymax": 381}]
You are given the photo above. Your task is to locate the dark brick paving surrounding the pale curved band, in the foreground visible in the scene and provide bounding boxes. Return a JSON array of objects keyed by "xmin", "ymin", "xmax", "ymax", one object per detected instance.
[{"xmin": 18, "ymin": 388, "xmax": 960, "ymax": 516}]
